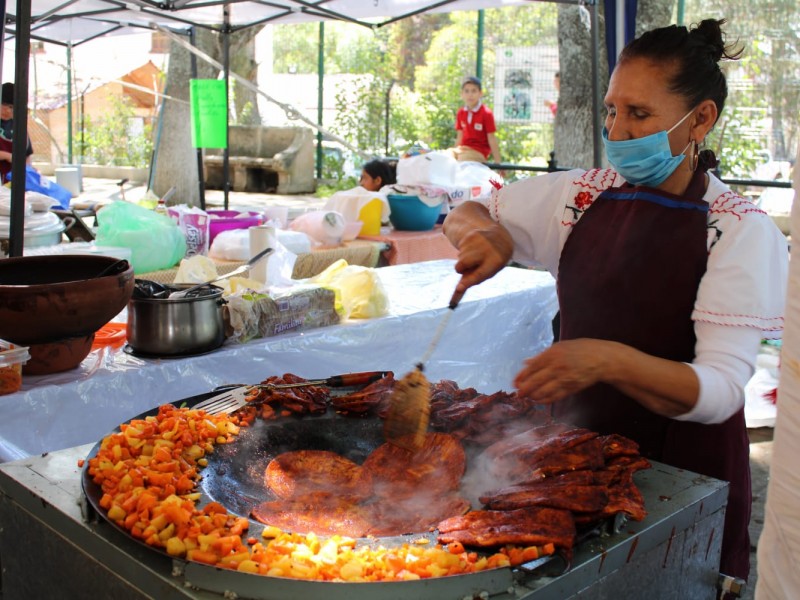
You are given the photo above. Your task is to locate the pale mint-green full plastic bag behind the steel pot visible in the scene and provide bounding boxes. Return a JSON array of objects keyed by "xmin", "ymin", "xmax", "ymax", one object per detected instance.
[{"xmin": 96, "ymin": 200, "xmax": 186, "ymax": 274}]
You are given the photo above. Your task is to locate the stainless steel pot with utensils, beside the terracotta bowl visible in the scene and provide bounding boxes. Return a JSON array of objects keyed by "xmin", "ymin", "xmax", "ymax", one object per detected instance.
[{"xmin": 127, "ymin": 286, "xmax": 225, "ymax": 356}]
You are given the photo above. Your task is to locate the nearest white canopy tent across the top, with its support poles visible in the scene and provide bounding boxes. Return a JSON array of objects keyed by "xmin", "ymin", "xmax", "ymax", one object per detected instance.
[{"xmin": 3, "ymin": 0, "xmax": 599, "ymax": 256}]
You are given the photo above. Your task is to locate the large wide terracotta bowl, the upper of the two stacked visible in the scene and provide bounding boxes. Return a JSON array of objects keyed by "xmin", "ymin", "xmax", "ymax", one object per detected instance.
[{"xmin": 0, "ymin": 254, "xmax": 134, "ymax": 356}]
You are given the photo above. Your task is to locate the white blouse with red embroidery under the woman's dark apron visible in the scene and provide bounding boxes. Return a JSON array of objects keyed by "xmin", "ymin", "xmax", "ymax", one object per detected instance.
[{"xmin": 485, "ymin": 169, "xmax": 788, "ymax": 423}]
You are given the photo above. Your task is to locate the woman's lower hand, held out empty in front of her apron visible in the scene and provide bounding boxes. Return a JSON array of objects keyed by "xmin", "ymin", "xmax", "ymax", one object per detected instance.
[{"xmin": 514, "ymin": 338, "xmax": 618, "ymax": 404}]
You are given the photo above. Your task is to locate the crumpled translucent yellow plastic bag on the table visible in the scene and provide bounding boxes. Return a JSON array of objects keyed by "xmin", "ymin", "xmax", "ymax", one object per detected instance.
[{"xmin": 309, "ymin": 258, "xmax": 389, "ymax": 319}]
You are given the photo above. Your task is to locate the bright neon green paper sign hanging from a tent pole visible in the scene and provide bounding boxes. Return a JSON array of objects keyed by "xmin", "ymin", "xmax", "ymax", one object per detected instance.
[{"xmin": 189, "ymin": 79, "xmax": 228, "ymax": 148}]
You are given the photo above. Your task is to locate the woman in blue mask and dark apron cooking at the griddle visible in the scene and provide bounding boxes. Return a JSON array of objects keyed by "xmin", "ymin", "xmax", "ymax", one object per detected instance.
[{"xmin": 444, "ymin": 20, "xmax": 788, "ymax": 579}]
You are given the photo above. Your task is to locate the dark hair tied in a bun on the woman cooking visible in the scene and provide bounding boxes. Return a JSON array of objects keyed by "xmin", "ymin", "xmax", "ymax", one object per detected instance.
[{"xmin": 617, "ymin": 19, "xmax": 742, "ymax": 118}]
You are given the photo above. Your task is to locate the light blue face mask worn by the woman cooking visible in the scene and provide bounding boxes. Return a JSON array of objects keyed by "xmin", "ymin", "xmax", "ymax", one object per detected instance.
[{"xmin": 603, "ymin": 109, "xmax": 694, "ymax": 187}]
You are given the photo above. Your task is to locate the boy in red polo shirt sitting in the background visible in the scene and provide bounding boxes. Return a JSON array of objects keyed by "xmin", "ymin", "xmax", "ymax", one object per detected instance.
[{"xmin": 452, "ymin": 77, "xmax": 501, "ymax": 163}]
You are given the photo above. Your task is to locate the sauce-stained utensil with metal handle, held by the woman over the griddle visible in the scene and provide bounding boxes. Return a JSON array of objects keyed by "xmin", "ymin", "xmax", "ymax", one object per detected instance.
[{"xmin": 383, "ymin": 292, "xmax": 464, "ymax": 453}]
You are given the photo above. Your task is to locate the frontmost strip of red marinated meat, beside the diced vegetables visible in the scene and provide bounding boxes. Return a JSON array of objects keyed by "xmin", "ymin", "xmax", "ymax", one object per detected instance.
[{"xmin": 438, "ymin": 507, "xmax": 575, "ymax": 548}]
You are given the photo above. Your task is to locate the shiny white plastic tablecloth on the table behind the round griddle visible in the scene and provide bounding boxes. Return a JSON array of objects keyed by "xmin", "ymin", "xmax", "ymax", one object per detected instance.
[{"xmin": 0, "ymin": 260, "xmax": 557, "ymax": 461}]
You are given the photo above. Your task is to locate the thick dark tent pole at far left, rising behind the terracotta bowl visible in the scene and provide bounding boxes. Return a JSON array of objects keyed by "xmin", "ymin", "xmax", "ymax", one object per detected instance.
[{"xmin": 8, "ymin": 0, "xmax": 31, "ymax": 257}]
